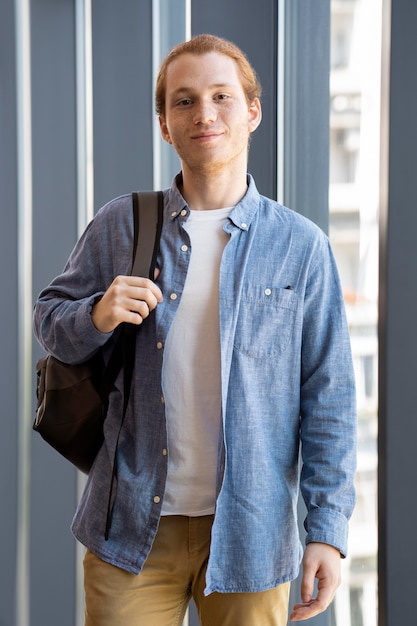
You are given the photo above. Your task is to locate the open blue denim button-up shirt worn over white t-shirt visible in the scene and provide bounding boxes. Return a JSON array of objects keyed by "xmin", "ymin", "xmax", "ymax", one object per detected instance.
[{"xmin": 34, "ymin": 177, "xmax": 356, "ymax": 593}]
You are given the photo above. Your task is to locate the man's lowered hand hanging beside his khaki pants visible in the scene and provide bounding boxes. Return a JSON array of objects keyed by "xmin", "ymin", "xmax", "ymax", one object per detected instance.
[{"xmin": 290, "ymin": 543, "xmax": 340, "ymax": 622}]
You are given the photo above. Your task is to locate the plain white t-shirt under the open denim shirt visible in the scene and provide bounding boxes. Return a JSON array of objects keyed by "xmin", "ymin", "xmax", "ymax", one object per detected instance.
[{"xmin": 162, "ymin": 208, "xmax": 231, "ymax": 516}]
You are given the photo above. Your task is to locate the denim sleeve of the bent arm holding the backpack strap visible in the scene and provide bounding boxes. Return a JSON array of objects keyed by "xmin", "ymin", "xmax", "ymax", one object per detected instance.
[{"xmin": 33, "ymin": 196, "xmax": 133, "ymax": 363}]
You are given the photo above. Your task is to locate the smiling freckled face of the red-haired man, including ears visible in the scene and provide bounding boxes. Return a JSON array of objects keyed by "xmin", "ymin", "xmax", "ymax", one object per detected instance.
[{"xmin": 160, "ymin": 52, "xmax": 261, "ymax": 173}]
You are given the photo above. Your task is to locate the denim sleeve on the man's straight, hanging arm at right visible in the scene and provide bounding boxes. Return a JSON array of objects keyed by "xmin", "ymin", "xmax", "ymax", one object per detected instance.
[{"xmin": 300, "ymin": 237, "xmax": 357, "ymax": 556}]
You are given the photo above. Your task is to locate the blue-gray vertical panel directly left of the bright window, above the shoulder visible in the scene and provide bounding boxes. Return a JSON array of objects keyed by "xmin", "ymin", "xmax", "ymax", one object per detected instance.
[{"xmin": 284, "ymin": 0, "xmax": 330, "ymax": 232}]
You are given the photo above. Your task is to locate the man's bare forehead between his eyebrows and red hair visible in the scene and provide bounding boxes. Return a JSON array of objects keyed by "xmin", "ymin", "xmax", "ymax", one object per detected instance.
[{"xmin": 166, "ymin": 52, "xmax": 242, "ymax": 93}]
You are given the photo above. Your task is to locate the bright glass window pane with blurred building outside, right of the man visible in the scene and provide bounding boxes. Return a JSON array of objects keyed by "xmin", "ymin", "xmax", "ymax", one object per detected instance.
[{"xmin": 329, "ymin": 0, "xmax": 382, "ymax": 626}]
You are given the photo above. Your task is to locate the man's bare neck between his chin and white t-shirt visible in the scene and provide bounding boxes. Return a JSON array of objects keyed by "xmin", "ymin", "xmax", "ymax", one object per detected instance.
[{"xmin": 181, "ymin": 166, "xmax": 248, "ymax": 211}]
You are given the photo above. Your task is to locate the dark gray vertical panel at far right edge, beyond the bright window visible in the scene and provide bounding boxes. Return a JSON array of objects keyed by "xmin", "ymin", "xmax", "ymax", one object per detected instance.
[{"xmin": 379, "ymin": 0, "xmax": 417, "ymax": 626}]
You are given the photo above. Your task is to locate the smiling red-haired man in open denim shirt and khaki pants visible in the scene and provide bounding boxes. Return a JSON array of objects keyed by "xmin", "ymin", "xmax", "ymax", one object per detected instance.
[{"xmin": 34, "ymin": 35, "xmax": 356, "ymax": 626}]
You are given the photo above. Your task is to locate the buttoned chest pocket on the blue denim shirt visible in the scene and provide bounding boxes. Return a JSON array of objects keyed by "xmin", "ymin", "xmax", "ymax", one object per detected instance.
[{"xmin": 234, "ymin": 286, "xmax": 299, "ymax": 359}]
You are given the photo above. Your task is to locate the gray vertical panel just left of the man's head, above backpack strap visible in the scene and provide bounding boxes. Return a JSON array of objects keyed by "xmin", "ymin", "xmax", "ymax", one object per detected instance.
[{"xmin": 93, "ymin": 0, "xmax": 154, "ymax": 208}]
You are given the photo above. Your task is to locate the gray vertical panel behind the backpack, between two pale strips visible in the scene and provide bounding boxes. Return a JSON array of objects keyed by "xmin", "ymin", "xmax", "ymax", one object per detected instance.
[{"xmin": 30, "ymin": 0, "xmax": 77, "ymax": 626}]
